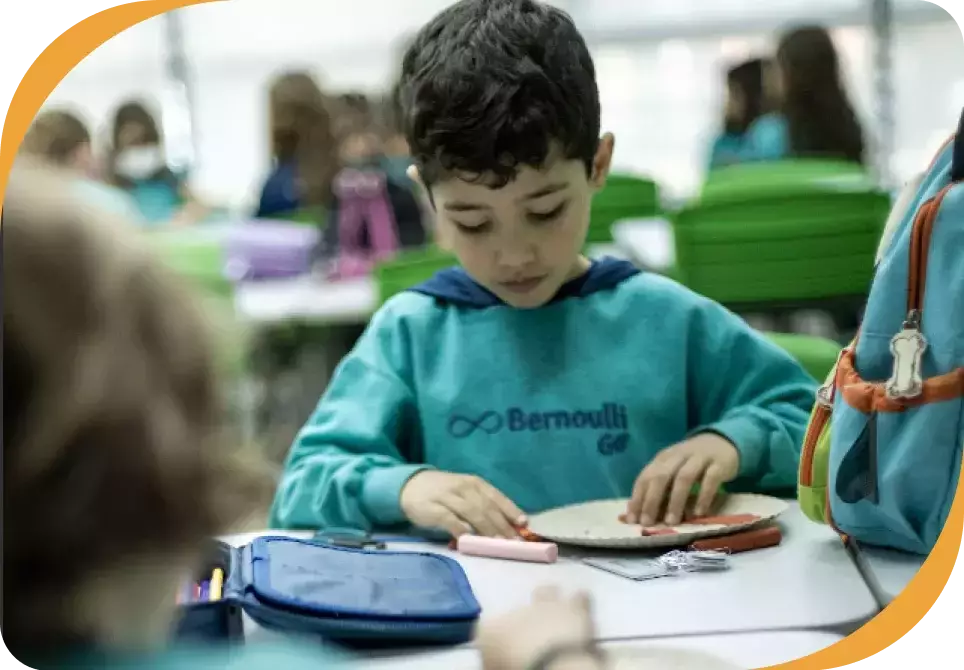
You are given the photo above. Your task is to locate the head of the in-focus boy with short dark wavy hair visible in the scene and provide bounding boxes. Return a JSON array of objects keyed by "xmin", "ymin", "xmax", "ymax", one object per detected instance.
[{"xmin": 401, "ymin": 0, "xmax": 613, "ymax": 308}]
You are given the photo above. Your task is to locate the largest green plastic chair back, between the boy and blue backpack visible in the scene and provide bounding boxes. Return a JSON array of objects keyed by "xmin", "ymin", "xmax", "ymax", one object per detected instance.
[{"xmin": 673, "ymin": 161, "xmax": 890, "ymax": 311}]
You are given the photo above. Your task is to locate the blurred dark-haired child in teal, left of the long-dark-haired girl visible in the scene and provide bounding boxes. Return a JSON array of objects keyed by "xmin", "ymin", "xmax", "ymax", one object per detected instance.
[{"xmin": 709, "ymin": 58, "xmax": 764, "ymax": 169}]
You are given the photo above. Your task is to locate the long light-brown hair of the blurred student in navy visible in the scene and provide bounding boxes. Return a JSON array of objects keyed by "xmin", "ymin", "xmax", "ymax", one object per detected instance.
[{"xmin": 268, "ymin": 72, "xmax": 339, "ymax": 206}]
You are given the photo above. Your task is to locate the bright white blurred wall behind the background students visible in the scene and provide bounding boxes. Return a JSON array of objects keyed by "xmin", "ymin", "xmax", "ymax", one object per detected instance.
[{"xmin": 37, "ymin": 0, "xmax": 964, "ymax": 210}]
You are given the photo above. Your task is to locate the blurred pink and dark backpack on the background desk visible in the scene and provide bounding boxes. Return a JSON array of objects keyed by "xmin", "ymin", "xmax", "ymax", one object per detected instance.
[{"xmin": 323, "ymin": 168, "xmax": 425, "ymax": 279}]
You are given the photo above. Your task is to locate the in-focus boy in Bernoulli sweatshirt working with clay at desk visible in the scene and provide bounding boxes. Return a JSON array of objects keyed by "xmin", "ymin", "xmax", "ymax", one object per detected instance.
[{"xmin": 272, "ymin": 0, "xmax": 816, "ymax": 537}]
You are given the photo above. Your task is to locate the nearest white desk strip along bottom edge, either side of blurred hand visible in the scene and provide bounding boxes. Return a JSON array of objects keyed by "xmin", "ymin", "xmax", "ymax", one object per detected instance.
[{"xmin": 365, "ymin": 631, "xmax": 843, "ymax": 670}]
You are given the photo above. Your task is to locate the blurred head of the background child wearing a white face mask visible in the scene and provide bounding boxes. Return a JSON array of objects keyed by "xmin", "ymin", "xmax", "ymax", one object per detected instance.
[{"xmin": 108, "ymin": 102, "xmax": 168, "ymax": 185}]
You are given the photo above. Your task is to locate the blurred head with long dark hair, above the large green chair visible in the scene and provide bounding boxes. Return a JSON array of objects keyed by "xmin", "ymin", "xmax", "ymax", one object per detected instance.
[{"xmin": 766, "ymin": 26, "xmax": 864, "ymax": 163}]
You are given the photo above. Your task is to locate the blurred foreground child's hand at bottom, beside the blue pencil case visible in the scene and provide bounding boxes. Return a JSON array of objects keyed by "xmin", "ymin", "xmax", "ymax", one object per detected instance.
[{"xmin": 475, "ymin": 588, "xmax": 598, "ymax": 670}]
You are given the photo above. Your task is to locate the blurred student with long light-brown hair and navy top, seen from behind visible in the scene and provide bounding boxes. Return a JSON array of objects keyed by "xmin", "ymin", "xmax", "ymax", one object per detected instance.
[{"xmin": 256, "ymin": 72, "xmax": 341, "ymax": 223}]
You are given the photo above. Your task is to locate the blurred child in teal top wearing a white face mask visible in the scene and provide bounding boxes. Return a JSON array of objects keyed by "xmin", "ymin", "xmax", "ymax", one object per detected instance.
[{"xmin": 107, "ymin": 102, "xmax": 208, "ymax": 225}]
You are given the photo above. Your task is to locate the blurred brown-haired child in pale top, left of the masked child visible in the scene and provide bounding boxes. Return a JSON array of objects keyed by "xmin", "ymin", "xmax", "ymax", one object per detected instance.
[{"xmin": 21, "ymin": 110, "xmax": 147, "ymax": 226}]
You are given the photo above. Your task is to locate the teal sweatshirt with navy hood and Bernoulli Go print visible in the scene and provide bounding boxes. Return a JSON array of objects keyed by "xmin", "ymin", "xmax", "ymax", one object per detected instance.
[{"xmin": 271, "ymin": 259, "xmax": 816, "ymax": 530}]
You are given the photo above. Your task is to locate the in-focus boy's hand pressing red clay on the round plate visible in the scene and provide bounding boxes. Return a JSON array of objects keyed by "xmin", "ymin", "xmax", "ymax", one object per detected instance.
[{"xmin": 626, "ymin": 433, "xmax": 740, "ymax": 526}]
